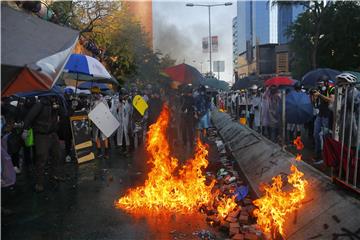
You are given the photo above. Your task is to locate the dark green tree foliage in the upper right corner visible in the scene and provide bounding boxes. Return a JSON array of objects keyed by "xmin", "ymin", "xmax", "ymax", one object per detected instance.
[{"xmin": 287, "ymin": 1, "xmax": 360, "ymax": 77}]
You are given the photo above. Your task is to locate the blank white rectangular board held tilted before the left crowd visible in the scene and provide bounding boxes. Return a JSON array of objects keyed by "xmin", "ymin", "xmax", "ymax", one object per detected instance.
[{"xmin": 88, "ymin": 102, "xmax": 120, "ymax": 138}]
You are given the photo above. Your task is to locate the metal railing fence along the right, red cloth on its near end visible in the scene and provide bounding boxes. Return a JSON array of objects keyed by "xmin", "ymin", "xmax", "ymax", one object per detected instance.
[{"xmin": 217, "ymin": 84, "xmax": 360, "ymax": 193}]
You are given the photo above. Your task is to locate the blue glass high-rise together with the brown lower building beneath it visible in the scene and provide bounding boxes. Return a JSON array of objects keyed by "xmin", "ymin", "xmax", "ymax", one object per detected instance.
[{"xmin": 233, "ymin": 0, "xmax": 304, "ymax": 78}]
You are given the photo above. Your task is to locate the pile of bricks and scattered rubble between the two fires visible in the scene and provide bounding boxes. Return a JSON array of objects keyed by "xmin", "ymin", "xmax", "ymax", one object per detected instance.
[{"xmin": 202, "ymin": 129, "xmax": 265, "ymax": 240}]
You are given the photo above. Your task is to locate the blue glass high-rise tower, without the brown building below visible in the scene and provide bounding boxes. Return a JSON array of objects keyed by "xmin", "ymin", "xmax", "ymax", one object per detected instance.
[{"xmin": 233, "ymin": 0, "xmax": 304, "ymax": 77}]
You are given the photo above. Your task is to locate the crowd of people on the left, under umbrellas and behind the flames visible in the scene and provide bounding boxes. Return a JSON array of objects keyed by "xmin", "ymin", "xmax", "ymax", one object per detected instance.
[{"xmin": 1, "ymin": 84, "xmax": 215, "ymax": 192}]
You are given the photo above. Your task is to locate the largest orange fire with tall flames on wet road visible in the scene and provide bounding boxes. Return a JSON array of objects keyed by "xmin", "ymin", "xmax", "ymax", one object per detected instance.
[{"xmin": 116, "ymin": 105, "xmax": 215, "ymax": 212}]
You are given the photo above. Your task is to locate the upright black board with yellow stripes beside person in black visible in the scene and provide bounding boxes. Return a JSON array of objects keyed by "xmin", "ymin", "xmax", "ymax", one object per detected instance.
[{"xmin": 70, "ymin": 112, "xmax": 95, "ymax": 163}]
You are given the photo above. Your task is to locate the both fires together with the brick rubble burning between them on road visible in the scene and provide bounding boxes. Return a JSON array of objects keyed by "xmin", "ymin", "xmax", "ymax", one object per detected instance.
[{"xmin": 116, "ymin": 105, "xmax": 307, "ymax": 239}]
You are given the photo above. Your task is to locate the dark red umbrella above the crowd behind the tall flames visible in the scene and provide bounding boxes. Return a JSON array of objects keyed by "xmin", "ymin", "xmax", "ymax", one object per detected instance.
[{"xmin": 163, "ymin": 63, "xmax": 203, "ymax": 85}]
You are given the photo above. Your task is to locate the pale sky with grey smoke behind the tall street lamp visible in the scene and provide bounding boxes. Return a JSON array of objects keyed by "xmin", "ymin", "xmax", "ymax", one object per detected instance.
[{"xmin": 153, "ymin": 0, "xmax": 236, "ymax": 82}]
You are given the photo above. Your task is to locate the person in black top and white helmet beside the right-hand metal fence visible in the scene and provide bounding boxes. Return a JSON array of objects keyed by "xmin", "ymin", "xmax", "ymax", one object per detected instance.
[{"xmin": 312, "ymin": 75, "xmax": 335, "ymax": 164}]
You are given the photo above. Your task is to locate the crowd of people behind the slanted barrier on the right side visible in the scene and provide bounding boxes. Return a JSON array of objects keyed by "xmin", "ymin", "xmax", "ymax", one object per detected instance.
[{"xmin": 218, "ymin": 73, "xmax": 360, "ymax": 164}]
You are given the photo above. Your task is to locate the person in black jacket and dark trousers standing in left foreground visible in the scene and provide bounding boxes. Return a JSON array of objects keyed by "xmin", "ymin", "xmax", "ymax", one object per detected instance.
[{"xmin": 23, "ymin": 96, "xmax": 65, "ymax": 192}]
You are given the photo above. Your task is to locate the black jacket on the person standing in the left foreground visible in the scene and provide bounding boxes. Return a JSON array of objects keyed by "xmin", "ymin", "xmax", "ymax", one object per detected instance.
[{"xmin": 24, "ymin": 98, "xmax": 64, "ymax": 134}]
